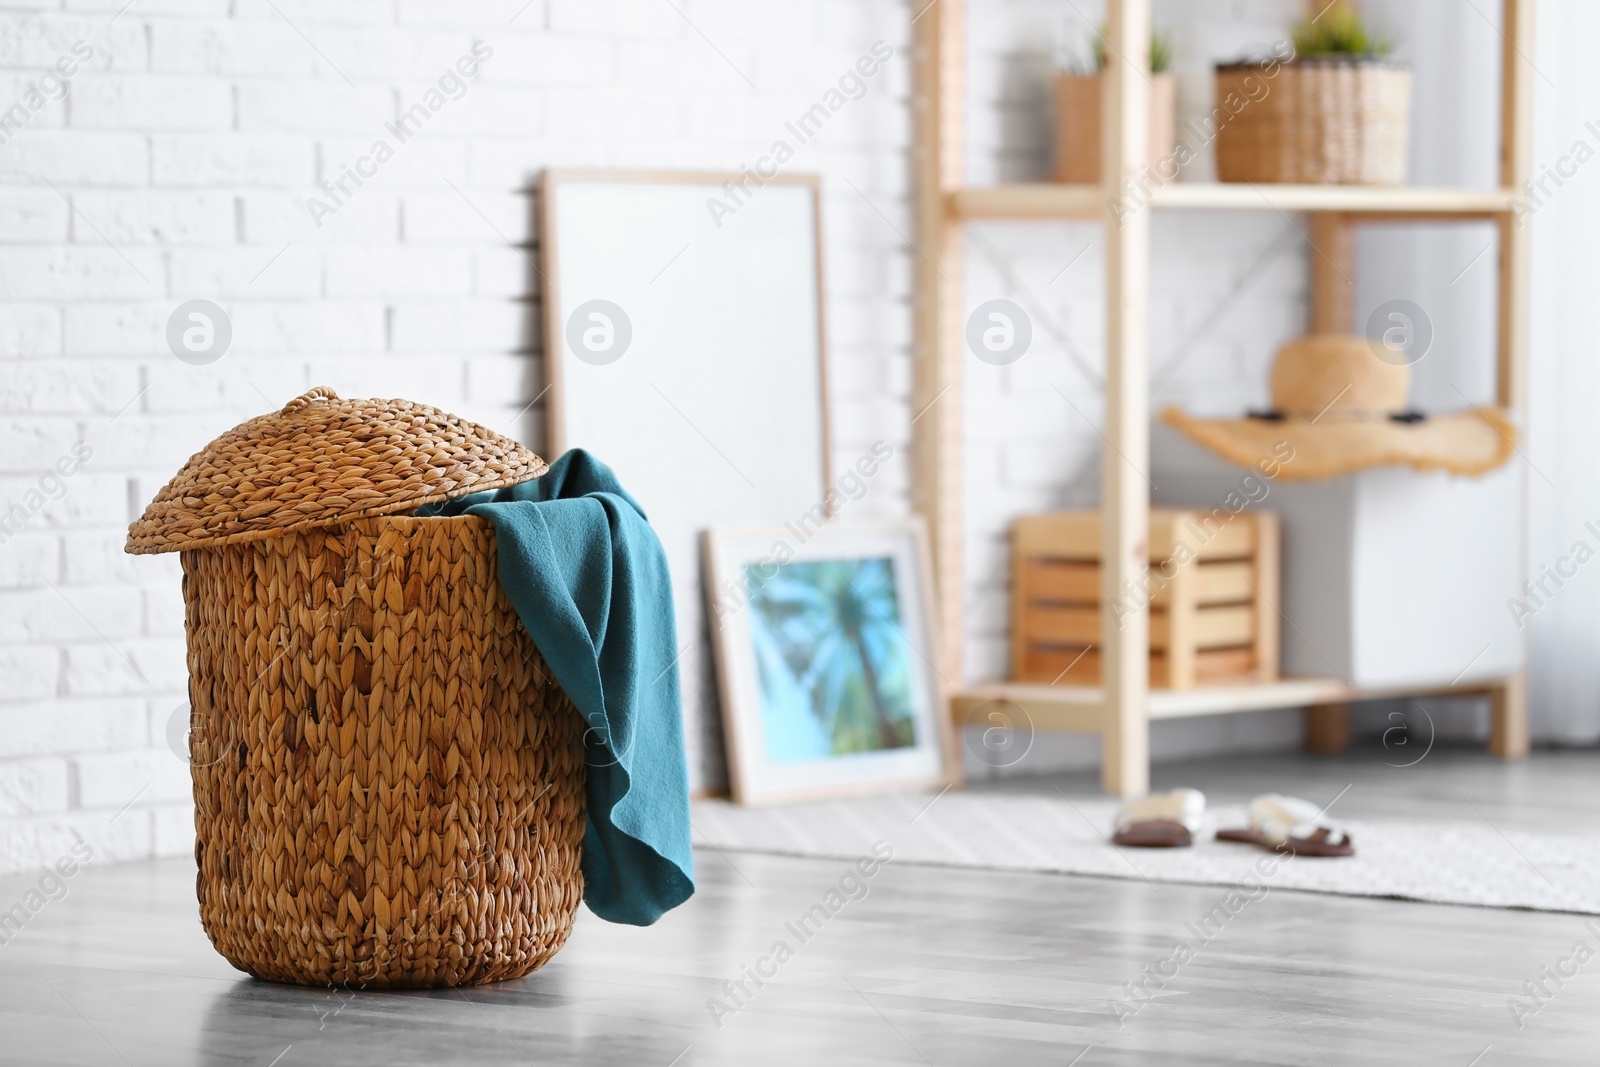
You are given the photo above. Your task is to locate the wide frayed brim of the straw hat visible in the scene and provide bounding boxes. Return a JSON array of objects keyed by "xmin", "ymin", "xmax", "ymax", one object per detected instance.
[{"xmin": 1162, "ymin": 408, "xmax": 1517, "ymax": 482}]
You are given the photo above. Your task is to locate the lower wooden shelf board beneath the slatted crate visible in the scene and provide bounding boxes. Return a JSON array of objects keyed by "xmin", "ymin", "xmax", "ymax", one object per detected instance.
[{"xmin": 950, "ymin": 678, "xmax": 1506, "ymax": 733}]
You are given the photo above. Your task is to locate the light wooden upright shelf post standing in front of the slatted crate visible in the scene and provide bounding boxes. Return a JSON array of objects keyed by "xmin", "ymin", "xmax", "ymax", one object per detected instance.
[{"xmin": 1101, "ymin": 0, "xmax": 1152, "ymax": 797}]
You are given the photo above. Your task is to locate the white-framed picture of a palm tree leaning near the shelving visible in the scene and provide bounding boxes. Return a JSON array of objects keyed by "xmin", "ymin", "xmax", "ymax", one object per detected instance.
[{"xmin": 704, "ymin": 520, "xmax": 954, "ymax": 803}]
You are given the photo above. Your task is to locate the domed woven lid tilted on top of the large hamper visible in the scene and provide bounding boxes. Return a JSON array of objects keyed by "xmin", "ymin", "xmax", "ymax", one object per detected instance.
[{"xmin": 125, "ymin": 387, "xmax": 549, "ymax": 553}]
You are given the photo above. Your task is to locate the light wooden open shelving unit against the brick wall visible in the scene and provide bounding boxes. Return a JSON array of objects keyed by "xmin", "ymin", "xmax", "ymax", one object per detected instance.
[{"xmin": 912, "ymin": 0, "xmax": 1533, "ymax": 795}]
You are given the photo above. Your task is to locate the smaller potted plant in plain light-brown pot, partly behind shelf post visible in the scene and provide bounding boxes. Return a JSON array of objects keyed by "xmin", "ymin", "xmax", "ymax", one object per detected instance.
[{"xmin": 1056, "ymin": 32, "xmax": 1178, "ymax": 184}]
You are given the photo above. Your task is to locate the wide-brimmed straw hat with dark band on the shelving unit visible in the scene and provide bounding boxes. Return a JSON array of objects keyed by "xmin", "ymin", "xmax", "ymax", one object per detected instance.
[{"xmin": 1162, "ymin": 334, "xmax": 1517, "ymax": 480}]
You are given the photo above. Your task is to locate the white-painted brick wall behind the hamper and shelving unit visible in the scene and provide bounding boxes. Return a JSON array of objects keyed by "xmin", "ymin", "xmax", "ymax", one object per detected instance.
[{"xmin": 0, "ymin": 0, "xmax": 1363, "ymax": 872}]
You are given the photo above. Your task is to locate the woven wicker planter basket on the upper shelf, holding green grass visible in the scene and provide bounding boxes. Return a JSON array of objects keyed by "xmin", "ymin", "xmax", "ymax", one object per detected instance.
[{"xmin": 1214, "ymin": 59, "xmax": 1411, "ymax": 186}]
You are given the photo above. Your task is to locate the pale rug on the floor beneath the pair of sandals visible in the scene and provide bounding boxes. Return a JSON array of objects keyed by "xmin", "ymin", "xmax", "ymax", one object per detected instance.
[{"xmin": 693, "ymin": 790, "xmax": 1600, "ymax": 915}]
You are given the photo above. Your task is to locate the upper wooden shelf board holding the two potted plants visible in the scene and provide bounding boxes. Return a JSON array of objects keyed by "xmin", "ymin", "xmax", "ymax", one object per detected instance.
[{"xmin": 947, "ymin": 182, "xmax": 1515, "ymax": 219}]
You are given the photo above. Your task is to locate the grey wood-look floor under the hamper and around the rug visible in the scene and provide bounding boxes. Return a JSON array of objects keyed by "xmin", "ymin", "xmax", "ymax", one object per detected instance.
[{"xmin": 0, "ymin": 750, "xmax": 1600, "ymax": 1067}]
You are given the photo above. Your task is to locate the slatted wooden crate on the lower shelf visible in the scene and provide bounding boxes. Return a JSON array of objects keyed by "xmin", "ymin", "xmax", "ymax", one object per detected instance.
[{"xmin": 1011, "ymin": 509, "xmax": 1280, "ymax": 689}]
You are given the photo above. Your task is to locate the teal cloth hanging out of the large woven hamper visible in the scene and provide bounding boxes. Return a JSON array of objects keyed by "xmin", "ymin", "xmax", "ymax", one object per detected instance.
[{"xmin": 416, "ymin": 450, "xmax": 694, "ymax": 926}]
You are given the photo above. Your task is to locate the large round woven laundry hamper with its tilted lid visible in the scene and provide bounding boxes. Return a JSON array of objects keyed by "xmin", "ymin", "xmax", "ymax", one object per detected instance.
[{"xmin": 126, "ymin": 389, "xmax": 584, "ymax": 989}]
